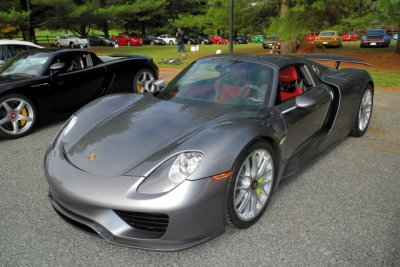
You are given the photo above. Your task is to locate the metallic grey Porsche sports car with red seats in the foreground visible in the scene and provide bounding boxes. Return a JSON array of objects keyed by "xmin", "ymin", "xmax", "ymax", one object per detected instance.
[{"xmin": 44, "ymin": 54, "xmax": 374, "ymax": 250}]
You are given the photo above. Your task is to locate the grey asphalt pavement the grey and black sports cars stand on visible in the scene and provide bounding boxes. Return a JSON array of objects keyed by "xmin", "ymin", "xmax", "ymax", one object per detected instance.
[{"xmin": 0, "ymin": 86, "xmax": 400, "ymax": 266}]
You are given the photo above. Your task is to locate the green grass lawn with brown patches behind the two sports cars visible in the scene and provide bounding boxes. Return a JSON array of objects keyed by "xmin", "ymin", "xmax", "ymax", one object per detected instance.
[{"xmin": 47, "ymin": 41, "xmax": 400, "ymax": 90}]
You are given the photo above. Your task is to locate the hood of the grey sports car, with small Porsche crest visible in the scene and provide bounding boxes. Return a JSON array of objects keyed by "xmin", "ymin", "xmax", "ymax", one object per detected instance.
[{"xmin": 62, "ymin": 95, "xmax": 247, "ymax": 179}]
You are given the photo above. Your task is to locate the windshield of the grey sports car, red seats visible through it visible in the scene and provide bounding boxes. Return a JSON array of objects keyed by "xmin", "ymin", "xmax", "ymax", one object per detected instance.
[{"xmin": 161, "ymin": 58, "xmax": 273, "ymax": 106}]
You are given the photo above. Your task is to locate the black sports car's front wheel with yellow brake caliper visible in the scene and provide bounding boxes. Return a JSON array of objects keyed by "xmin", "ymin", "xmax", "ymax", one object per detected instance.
[{"xmin": 0, "ymin": 94, "xmax": 37, "ymax": 139}]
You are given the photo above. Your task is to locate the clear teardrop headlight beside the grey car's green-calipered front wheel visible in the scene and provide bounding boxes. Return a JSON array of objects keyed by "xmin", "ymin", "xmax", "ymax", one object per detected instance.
[{"xmin": 138, "ymin": 151, "xmax": 203, "ymax": 194}]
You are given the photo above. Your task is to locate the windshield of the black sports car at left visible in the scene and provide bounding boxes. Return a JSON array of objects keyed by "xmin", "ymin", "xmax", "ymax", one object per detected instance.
[{"xmin": 0, "ymin": 52, "xmax": 51, "ymax": 76}]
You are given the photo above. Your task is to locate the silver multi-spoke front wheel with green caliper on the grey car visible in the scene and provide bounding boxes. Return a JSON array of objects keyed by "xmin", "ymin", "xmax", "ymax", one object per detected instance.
[{"xmin": 226, "ymin": 141, "xmax": 276, "ymax": 229}]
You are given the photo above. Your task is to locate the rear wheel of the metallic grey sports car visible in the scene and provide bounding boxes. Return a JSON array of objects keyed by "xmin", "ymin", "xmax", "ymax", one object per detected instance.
[{"xmin": 350, "ymin": 85, "xmax": 374, "ymax": 137}]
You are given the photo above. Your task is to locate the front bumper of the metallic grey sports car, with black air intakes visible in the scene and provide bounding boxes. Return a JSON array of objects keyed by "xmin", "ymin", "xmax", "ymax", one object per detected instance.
[{"xmin": 45, "ymin": 144, "xmax": 227, "ymax": 250}]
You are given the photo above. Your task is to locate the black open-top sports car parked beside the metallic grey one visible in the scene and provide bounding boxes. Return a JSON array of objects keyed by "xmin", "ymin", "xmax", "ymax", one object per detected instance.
[{"xmin": 0, "ymin": 49, "xmax": 158, "ymax": 138}]
